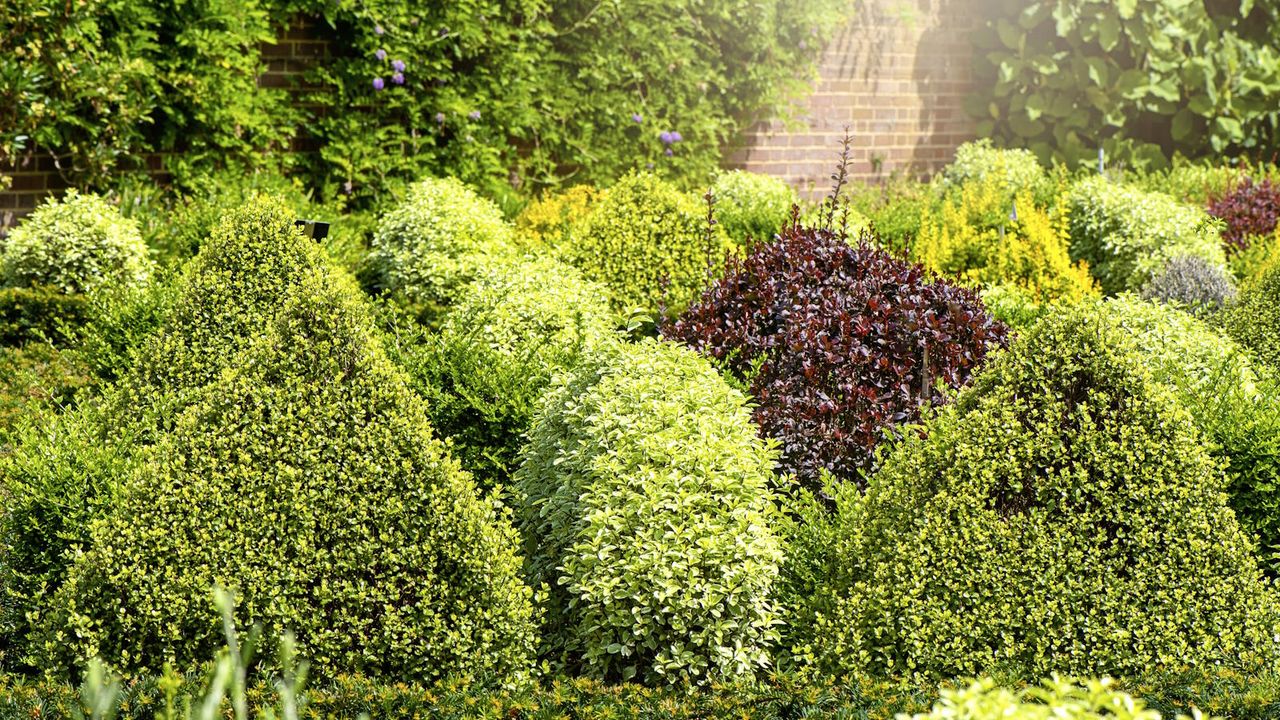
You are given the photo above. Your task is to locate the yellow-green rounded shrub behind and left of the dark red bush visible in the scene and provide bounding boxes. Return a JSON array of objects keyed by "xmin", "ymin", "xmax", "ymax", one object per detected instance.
[{"xmin": 561, "ymin": 173, "xmax": 730, "ymax": 313}]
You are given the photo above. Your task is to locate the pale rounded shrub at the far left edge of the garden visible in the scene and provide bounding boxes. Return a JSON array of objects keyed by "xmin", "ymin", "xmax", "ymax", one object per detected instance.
[{"xmin": 0, "ymin": 190, "xmax": 152, "ymax": 295}]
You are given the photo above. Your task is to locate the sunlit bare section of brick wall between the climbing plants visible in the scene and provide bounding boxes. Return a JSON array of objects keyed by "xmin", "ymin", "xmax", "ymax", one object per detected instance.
[{"xmin": 730, "ymin": 0, "xmax": 983, "ymax": 197}]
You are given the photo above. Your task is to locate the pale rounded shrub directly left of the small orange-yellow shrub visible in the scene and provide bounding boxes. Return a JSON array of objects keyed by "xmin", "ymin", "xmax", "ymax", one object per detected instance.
[{"xmin": 370, "ymin": 178, "xmax": 515, "ymax": 306}]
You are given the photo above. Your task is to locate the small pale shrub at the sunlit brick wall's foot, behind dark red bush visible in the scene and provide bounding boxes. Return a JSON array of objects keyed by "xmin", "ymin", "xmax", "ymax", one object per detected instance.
[{"xmin": 712, "ymin": 170, "xmax": 798, "ymax": 246}]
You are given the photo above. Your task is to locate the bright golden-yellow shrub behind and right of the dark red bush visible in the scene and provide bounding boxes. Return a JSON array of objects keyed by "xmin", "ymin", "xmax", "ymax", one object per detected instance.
[{"xmin": 911, "ymin": 176, "xmax": 1097, "ymax": 302}]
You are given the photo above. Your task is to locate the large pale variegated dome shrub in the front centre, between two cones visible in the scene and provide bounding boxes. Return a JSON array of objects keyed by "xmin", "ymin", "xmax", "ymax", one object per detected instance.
[{"xmin": 516, "ymin": 340, "xmax": 782, "ymax": 684}]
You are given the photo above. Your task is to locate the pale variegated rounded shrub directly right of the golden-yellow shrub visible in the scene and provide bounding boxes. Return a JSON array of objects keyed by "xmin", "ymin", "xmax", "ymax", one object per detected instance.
[{"xmin": 1068, "ymin": 176, "xmax": 1226, "ymax": 295}]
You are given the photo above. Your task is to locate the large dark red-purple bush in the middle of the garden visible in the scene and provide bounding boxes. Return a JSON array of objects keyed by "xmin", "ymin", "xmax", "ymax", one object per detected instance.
[{"xmin": 663, "ymin": 221, "xmax": 1009, "ymax": 487}]
